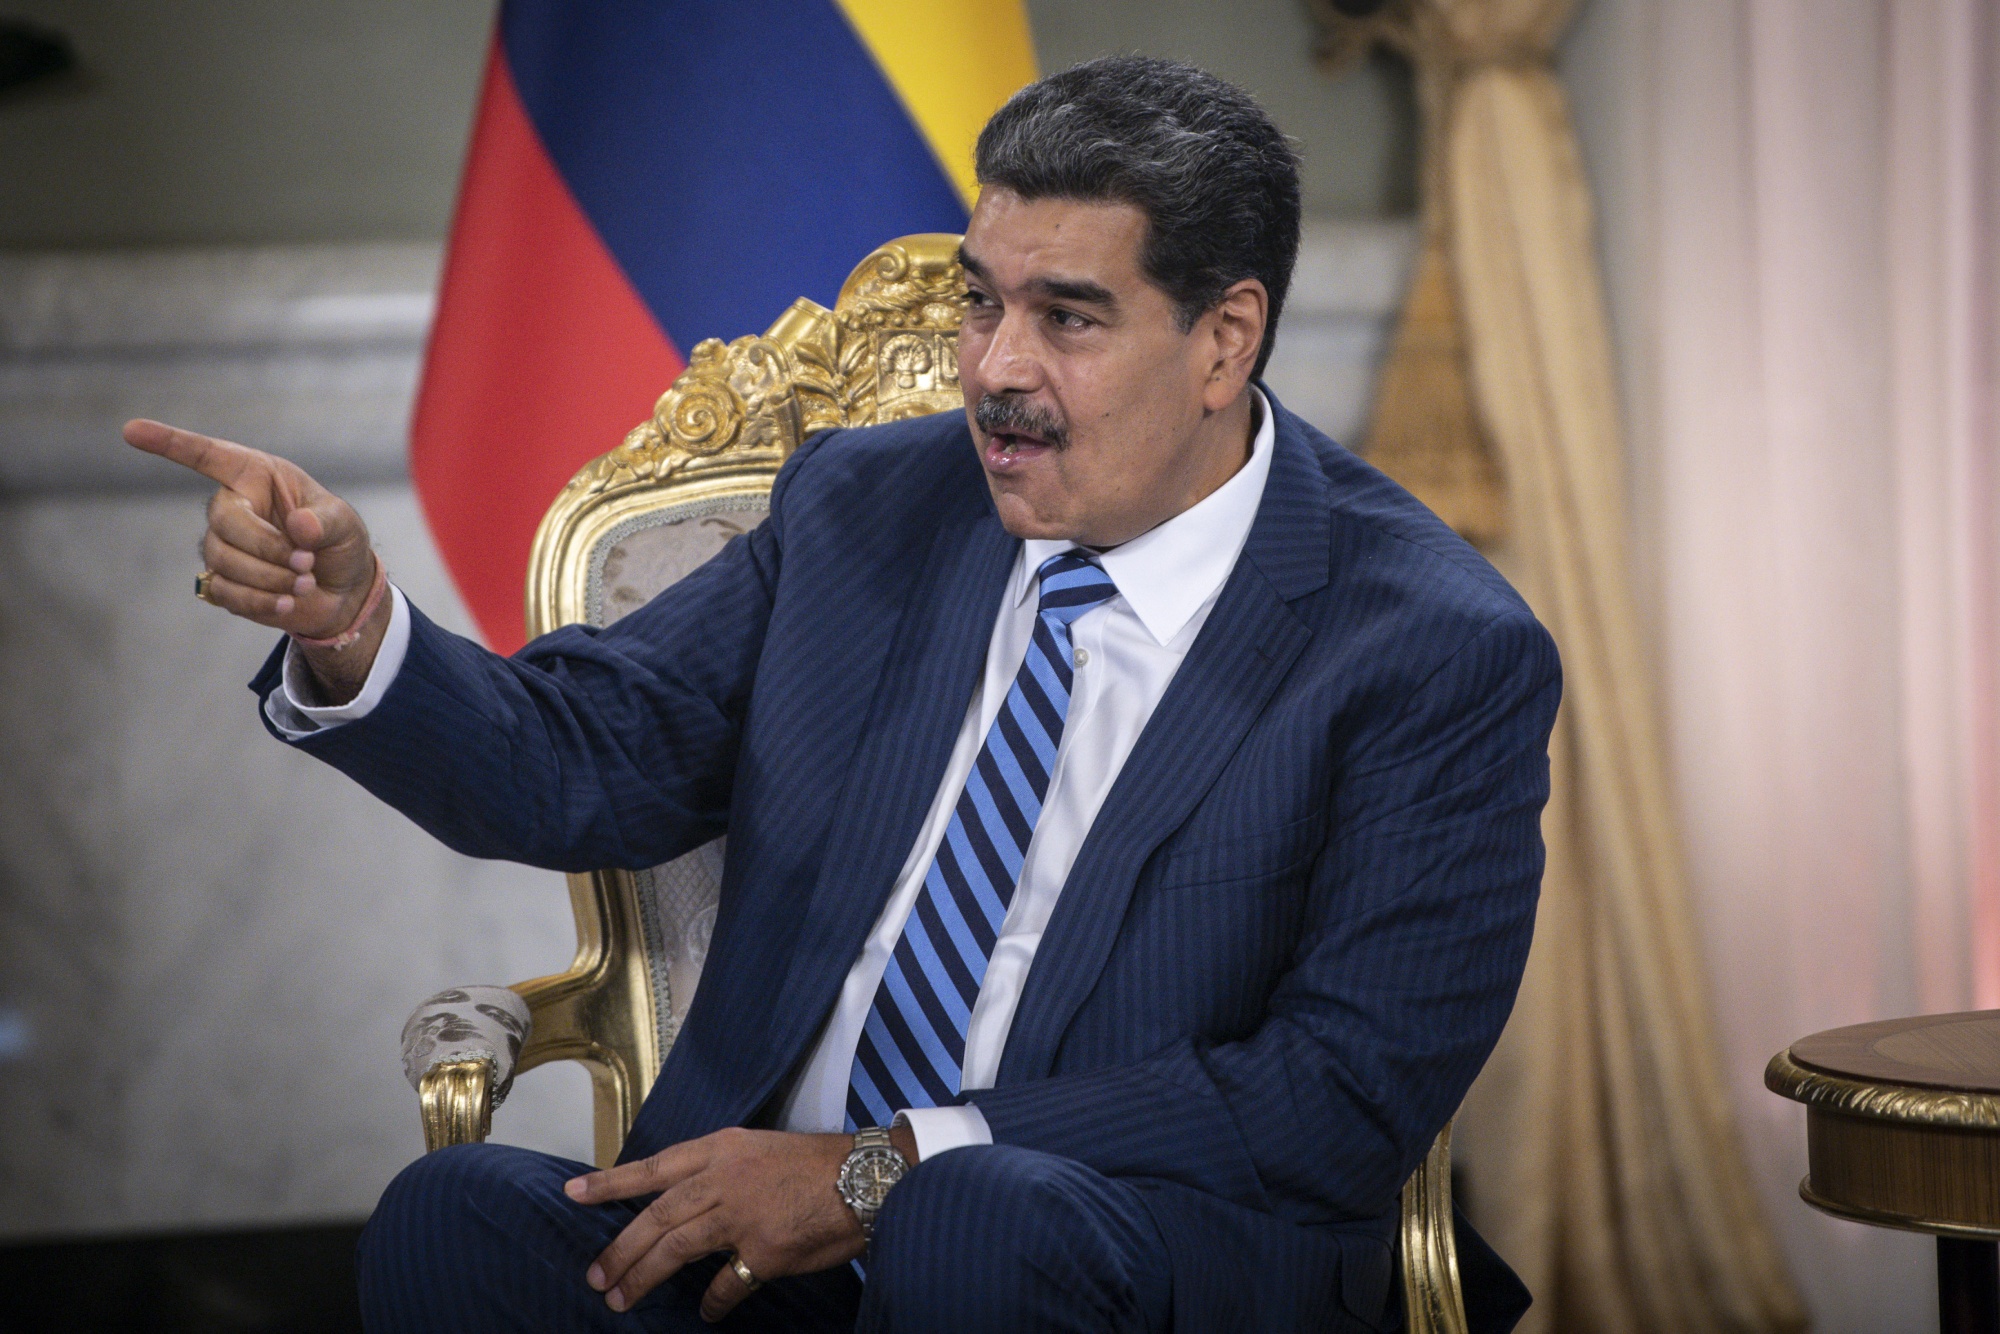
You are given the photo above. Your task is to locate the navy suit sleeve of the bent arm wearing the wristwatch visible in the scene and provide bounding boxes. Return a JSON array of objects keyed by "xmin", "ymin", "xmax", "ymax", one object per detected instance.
[{"xmin": 966, "ymin": 610, "xmax": 1560, "ymax": 1224}]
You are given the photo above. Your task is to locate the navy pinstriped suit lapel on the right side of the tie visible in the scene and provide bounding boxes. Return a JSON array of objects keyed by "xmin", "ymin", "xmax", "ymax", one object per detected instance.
[{"xmin": 998, "ymin": 404, "xmax": 1330, "ymax": 1086}]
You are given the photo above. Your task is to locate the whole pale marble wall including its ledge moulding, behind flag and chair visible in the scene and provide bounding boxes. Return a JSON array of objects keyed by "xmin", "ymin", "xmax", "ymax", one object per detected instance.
[{"xmin": 0, "ymin": 222, "xmax": 1412, "ymax": 1238}]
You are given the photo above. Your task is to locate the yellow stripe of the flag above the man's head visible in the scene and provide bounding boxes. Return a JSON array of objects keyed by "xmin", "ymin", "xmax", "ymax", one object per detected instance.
[{"xmin": 840, "ymin": 0, "xmax": 1034, "ymax": 208}]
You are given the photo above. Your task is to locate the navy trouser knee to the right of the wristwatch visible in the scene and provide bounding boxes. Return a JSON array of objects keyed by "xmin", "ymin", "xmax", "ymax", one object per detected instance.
[{"xmin": 860, "ymin": 1144, "xmax": 1158, "ymax": 1334}]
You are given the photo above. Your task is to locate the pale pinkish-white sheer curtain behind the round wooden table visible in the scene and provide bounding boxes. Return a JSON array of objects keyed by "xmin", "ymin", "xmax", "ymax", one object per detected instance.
[{"xmin": 1608, "ymin": 0, "xmax": 2000, "ymax": 1334}]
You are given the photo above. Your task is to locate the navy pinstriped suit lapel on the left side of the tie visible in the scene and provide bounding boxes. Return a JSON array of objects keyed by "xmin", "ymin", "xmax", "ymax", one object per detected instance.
[{"xmin": 768, "ymin": 480, "xmax": 1020, "ymax": 1080}]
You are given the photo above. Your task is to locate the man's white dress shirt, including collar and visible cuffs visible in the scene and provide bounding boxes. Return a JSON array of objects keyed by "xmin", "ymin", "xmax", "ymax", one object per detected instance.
[{"xmin": 266, "ymin": 390, "xmax": 1276, "ymax": 1158}]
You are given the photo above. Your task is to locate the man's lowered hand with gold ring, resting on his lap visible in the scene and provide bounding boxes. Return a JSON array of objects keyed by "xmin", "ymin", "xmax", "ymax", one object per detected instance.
[{"xmin": 564, "ymin": 1130, "xmax": 916, "ymax": 1320}]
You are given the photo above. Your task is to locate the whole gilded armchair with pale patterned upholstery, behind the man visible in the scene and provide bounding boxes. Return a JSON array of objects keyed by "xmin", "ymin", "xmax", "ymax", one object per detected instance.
[{"xmin": 404, "ymin": 234, "xmax": 1464, "ymax": 1334}]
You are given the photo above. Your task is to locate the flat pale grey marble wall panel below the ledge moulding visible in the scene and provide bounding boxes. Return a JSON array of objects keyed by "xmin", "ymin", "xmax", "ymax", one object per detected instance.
[{"xmin": 0, "ymin": 484, "xmax": 590, "ymax": 1234}]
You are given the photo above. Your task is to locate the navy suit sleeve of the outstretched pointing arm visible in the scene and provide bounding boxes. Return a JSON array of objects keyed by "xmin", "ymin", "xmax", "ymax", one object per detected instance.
[{"xmin": 250, "ymin": 436, "xmax": 824, "ymax": 870}]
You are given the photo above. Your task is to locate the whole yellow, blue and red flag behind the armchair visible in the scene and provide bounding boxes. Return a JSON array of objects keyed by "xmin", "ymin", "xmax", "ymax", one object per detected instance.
[{"xmin": 410, "ymin": 0, "xmax": 1034, "ymax": 652}]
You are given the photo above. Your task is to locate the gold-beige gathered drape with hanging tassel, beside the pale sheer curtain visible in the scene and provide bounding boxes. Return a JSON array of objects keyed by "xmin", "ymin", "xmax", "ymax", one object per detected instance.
[{"xmin": 1322, "ymin": 0, "xmax": 1804, "ymax": 1334}]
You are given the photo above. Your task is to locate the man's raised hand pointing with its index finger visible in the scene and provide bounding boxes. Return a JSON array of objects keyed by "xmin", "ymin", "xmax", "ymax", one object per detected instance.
[{"xmin": 124, "ymin": 418, "xmax": 390, "ymax": 704}]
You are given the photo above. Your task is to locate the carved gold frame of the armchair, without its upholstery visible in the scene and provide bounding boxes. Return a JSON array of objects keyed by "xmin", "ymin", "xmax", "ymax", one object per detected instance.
[{"xmin": 418, "ymin": 234, "xmax": 1466, "ymax": 1334}]
